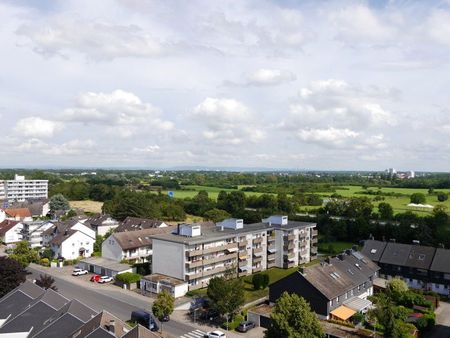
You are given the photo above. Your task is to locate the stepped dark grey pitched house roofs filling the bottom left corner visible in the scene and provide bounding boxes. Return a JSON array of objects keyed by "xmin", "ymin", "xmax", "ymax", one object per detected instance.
[{"xmin": 0, "ymin": 281, "xmax": 159, "ymax": 338}]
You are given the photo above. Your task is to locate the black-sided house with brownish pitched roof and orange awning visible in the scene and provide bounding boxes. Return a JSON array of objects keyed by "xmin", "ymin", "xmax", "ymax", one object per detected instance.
[{"xmin": 269, "ymin": 250, "xmax": 380, "ymax": 320}]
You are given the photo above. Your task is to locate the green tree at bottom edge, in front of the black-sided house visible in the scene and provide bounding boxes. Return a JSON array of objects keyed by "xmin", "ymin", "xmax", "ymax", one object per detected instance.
[{"xmin": 265, "ymin": 292, "xmax": 324, "ymax": 338}]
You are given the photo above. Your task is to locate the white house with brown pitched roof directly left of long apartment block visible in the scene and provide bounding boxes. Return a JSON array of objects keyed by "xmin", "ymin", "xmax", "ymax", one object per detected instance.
[{"xmin": 102, "ymin": 227, "xmax": 174, "ymax": 262}]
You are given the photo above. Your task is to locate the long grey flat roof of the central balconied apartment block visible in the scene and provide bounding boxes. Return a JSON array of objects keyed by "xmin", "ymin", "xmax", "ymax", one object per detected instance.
[{"xmin": 151, "ymin": 221, "xmax": 316, "ymax": 245}]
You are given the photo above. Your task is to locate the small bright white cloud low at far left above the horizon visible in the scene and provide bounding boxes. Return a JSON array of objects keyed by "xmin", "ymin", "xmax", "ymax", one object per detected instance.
[{"xmin": 14, "ymin": 116, "xmax": 63, "ymax": 138}]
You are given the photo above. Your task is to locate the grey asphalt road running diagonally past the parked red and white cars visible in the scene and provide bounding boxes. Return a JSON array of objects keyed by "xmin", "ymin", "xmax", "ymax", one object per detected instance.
[{"xmin": 27, "ymin": 267, "xmax": 196, "ymax": 337}]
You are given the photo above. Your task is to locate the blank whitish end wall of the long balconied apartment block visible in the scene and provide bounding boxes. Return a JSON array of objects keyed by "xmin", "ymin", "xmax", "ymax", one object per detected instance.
[{"xmin": 152, "ymin": 239, "xmax": 185, "ymax": 280}]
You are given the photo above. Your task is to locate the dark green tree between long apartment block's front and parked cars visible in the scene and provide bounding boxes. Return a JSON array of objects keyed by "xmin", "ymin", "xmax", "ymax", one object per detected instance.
[{"xmin": 207, "ymin": 277, "xmax": 245, "ymax": 319}]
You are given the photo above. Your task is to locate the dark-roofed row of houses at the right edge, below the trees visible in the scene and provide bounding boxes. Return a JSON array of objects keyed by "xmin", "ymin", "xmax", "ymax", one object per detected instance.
[{"xmin": 362, "ymin": 240, "xmax": 450, "ymax": 296}]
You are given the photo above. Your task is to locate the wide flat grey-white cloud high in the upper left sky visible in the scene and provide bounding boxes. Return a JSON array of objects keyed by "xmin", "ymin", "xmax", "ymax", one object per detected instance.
[{"xmin": 17, "ymin": 16, "xmax": 164, "ymax": 60}]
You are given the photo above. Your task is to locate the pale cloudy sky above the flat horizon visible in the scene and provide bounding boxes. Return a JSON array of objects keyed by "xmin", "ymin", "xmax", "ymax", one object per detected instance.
[{"xmin": 0, "ymin": 0, "xmax": 450, "ymax": 171}]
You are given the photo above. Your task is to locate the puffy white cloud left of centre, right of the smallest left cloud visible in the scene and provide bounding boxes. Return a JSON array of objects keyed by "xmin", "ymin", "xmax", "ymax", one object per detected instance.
[{"xmin": 62, "ymin": 90, "xmax": 174, "ymax": 137}]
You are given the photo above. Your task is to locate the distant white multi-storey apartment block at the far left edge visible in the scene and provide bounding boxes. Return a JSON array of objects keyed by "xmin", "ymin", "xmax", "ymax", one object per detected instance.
[{"xmin": 0, "ymin": 175, "xmax": 48, "ymax": 201}]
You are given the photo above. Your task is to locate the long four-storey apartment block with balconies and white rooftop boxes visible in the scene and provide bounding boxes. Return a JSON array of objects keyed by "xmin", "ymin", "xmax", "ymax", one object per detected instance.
[{"xmin": 152, "ymin": 216, "xmax": 317, "ymax": 290}]
